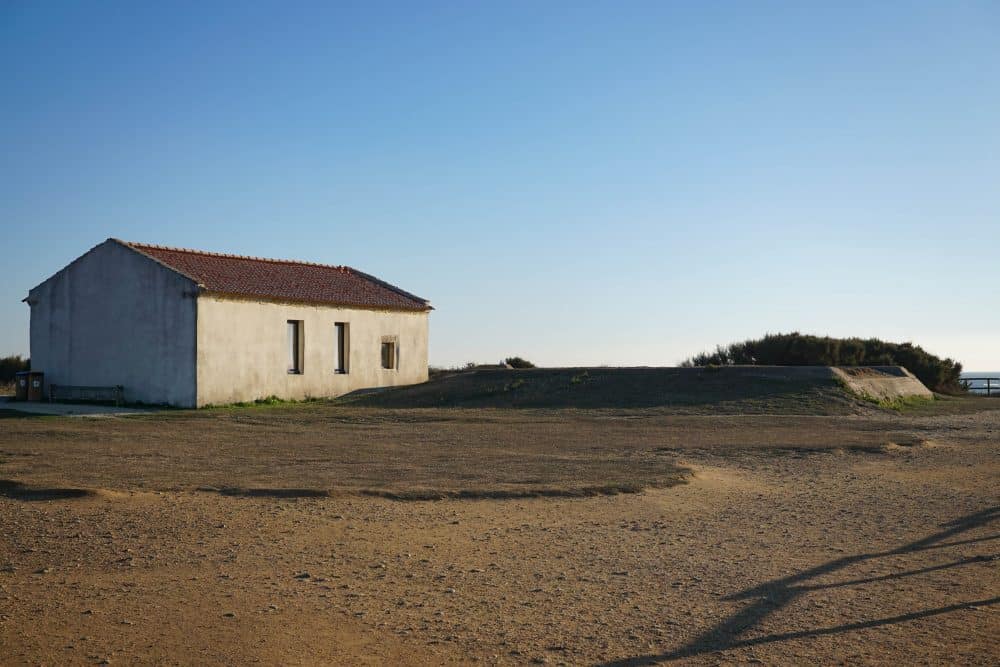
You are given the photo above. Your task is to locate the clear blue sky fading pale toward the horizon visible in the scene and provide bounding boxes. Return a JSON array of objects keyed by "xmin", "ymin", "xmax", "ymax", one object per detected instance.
[{"xmin": 0, "ymin": 0, "xmax": 1000, "ymax": 370}]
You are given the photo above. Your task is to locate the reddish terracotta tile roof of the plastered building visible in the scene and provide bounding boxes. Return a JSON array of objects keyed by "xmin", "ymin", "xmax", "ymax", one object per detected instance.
[{"xmin": 115, "ymin": 239, "xmax": 431, "ymax": 311}]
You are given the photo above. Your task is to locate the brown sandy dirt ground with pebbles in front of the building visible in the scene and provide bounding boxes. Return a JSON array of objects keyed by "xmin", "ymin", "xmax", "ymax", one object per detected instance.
[{"xmin": 0, "ymin": 406, "xmax": 1000, "ymax": 665}]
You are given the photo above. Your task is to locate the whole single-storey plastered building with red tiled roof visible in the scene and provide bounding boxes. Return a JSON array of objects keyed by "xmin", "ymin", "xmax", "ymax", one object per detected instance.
[{"xmin": 25, "ymin": 239, "xmax": 431, "ymax": 407}]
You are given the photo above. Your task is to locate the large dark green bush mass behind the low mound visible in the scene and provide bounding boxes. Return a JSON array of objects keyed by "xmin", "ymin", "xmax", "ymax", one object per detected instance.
[{"xmin": 681, "ymin": 332, "xmax": 963, "ymax": 394}]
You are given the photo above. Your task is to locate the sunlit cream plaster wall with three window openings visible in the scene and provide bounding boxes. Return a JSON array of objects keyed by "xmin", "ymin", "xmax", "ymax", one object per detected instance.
[{"xmin": 197, "ymin": 294, "xmax": 428, "ymax": 406}]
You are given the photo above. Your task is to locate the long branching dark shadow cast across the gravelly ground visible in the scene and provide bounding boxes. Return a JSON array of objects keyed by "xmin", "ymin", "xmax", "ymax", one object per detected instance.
[{"xmin": 601, "ymin": 507, "xmax": 1000, "ymax": 667}]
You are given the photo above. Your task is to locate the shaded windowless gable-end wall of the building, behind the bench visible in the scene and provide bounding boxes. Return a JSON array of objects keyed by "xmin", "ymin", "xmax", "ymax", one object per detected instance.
[{"xmin": 28, "ymin": 241, "xmax": 197, "ymax": 406}]
